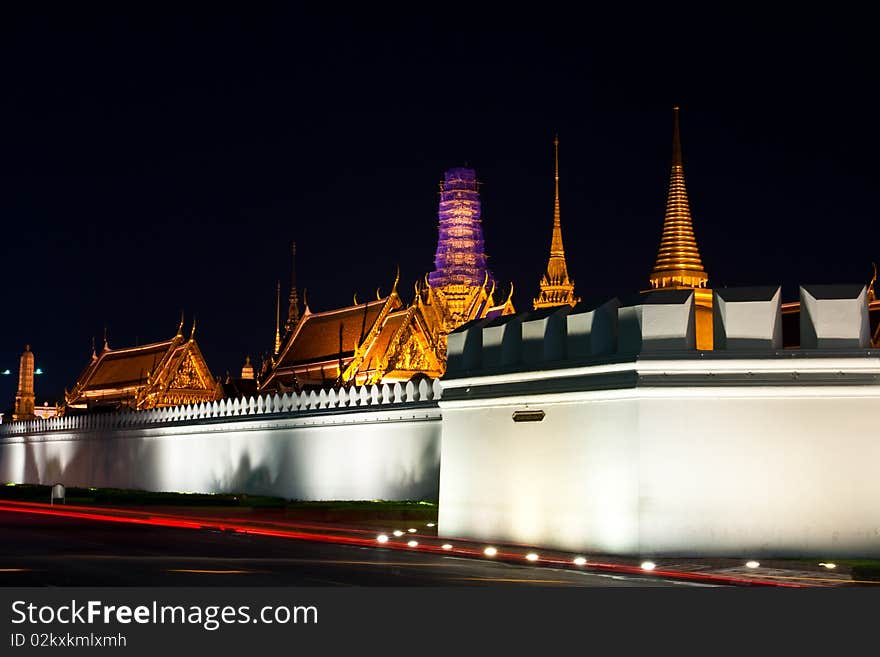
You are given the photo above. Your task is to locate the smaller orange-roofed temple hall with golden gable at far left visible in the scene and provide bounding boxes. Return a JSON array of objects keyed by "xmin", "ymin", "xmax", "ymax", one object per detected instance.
[{"xmin": 63, "ymin": 320, "xmax": 223, "ymax": 413}]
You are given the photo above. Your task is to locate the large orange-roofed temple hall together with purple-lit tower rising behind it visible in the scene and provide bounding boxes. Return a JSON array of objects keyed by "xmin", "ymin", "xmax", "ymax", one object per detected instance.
[{"xmin": 259, "ymin": 168, "xmax": 514, "ymax": 392}]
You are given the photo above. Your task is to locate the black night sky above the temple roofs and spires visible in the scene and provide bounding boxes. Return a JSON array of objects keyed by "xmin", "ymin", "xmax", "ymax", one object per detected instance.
[{"xmin": 0, "ymin": 3, "xmax": 880, "ymax": 408}]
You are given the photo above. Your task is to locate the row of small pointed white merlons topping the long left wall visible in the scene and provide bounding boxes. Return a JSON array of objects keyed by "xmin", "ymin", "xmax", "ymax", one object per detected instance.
[{"xmin": 0, "ymin": 379, "xmax": 442, "ymax": 437}]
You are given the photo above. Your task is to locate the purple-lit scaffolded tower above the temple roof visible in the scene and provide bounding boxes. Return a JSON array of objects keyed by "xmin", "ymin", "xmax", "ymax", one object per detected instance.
[{"xmin": 428, "ymin": 167, "xmax": 494, "ymax": 288}]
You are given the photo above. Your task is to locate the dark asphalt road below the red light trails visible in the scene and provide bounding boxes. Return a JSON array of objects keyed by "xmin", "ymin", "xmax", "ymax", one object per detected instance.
[{"xmin": 0, "ymin": 511, "xmax": 705, "ymax": 587}]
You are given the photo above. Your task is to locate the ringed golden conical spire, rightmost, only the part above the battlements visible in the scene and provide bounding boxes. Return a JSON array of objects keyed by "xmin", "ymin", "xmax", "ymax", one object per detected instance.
[{"xmin": 650, "ymin": 106, "xmax": 709, "ymax": 288}]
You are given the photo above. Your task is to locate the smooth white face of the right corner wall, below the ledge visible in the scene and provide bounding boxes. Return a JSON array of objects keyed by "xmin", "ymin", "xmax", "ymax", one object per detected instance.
[{"xmin": 438, "ymin": 386, "xmax": 880, "ymax": 557}]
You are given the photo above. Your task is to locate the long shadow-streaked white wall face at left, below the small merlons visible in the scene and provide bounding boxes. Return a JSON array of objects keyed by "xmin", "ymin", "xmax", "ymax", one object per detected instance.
[{"xmin": 0, "ymin": 407, "xmax": 440, "ymax": 500}]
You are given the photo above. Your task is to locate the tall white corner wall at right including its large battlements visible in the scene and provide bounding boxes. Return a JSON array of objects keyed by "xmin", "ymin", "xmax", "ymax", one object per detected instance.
[{"xmin": 438, "ymin": 286, "xmax": 880, "ymax": 557}]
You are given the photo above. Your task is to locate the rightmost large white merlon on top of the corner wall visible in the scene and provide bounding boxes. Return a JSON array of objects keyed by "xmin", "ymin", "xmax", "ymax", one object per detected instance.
[{"xmin": 800, "ymin": 285, "xmax": 871, "ymax": 349}]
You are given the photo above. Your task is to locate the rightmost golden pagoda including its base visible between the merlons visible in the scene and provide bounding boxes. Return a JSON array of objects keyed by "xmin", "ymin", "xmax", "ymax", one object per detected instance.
[{"xmin": 649, "ymin": 107, "xmax": 713, "ymax": 350}]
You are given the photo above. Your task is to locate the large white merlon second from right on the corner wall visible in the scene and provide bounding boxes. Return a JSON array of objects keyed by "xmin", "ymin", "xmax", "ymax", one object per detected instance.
[{"xmin": 712, "ymin": 285, "xmax": 782, "ymax": 351}]
